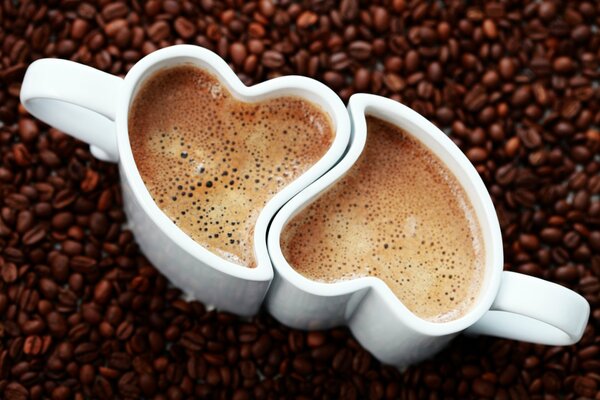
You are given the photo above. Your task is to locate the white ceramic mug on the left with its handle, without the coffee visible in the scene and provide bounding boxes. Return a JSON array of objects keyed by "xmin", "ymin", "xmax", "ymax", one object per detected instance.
[{"xmin": 21, "ymin": 45, "xmax": 350, "ymax": 315}]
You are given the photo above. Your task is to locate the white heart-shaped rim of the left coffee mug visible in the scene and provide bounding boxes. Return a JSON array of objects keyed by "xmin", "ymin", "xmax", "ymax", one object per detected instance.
[{"xmin": 115, "ymin": 44, "xmax": 350, "ymax": 281}]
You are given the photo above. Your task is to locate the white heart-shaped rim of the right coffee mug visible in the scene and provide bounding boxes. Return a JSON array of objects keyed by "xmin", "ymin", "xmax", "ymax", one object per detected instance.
[{"xmin": 267, "ymin": 93, "xmax": 503, "ymax": 336}]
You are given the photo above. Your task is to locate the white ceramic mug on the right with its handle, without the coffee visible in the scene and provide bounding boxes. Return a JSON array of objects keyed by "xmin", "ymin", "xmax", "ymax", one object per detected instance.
[{"xmin": 266, "ymin": 94, "xmax": 590, "ymax": 367}]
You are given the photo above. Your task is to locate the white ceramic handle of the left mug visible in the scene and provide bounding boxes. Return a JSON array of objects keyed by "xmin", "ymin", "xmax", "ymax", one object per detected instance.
[{"xmin": 21, "ymin": 58, "xmax": 123, "ymax": 162}]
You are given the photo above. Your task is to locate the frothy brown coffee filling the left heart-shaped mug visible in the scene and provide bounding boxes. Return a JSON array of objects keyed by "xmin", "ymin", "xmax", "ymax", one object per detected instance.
[{"xmin": 129, "ymin": 65, "xmax": 334, "ymax": 267}]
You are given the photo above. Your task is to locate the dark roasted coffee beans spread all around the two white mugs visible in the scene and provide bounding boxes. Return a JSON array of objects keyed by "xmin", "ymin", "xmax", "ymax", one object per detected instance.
[{"xmin": 0, "ymin": 0, "xmax": 600, "ymax": 400}]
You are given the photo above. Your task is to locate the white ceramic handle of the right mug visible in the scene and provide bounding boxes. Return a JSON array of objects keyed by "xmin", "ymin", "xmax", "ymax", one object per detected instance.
[{"xmin": 466, "ymin": 271, "xmax": 590, "ymax": 346}]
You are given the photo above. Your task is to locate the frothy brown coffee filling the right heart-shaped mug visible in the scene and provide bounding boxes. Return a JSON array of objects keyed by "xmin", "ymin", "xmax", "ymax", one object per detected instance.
[{"xmin": 281, "ymin": 117, "xmax": 484, "ymax": 322}]
